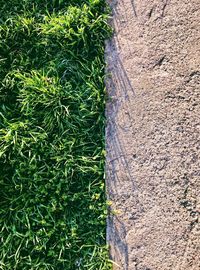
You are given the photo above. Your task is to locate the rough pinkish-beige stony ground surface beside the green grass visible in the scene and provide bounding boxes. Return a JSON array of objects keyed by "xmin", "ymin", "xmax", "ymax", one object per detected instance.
[{"xmin": 106, "ymin": 0, "xmax": 200, "ymax": 270}]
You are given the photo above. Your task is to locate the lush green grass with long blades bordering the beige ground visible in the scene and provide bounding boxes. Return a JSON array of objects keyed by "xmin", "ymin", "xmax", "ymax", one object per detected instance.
[{"xmin": 0, "ymin": 0, "xmax": 111, "ymax": 270}]
